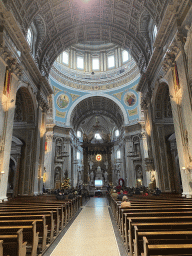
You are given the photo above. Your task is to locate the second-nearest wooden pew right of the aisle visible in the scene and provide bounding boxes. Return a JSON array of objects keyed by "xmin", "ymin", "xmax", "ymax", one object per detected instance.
[{"xmin": 134, "ymin": 230, "xmax": 192, "ymax": 256}]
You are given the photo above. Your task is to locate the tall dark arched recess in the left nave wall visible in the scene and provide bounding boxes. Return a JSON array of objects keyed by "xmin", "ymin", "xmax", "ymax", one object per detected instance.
[{"xmin": 11, "ymin": 87, "xmax": 36, "ymax": 196}]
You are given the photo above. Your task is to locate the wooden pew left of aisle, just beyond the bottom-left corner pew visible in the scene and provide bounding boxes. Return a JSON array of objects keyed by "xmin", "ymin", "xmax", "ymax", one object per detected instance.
[{"xmin": 0, "ymin": 221, "xmax": 39, "ymax": 256}]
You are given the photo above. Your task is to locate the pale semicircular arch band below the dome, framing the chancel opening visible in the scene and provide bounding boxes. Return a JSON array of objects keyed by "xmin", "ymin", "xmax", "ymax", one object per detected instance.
[{"xmin": 66, "ymin": 92, "xmax": 129, "ymax": 126}]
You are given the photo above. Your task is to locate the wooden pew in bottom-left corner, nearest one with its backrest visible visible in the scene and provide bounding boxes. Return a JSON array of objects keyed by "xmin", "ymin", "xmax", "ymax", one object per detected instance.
[{"xmin": 0, "ymin": 229, "xmax": 27, "ymax": 256}]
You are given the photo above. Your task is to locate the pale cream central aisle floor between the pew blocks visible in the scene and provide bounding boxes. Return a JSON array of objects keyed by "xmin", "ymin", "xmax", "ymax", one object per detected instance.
[{"xmin": 51, "ymin": 198, "xmax": 120, "ymax": 256}]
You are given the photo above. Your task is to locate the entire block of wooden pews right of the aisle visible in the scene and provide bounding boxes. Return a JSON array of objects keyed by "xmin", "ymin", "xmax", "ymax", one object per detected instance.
[{"xmin": 108, "ymin": 195, "xmax": 192, "ymax": 256}]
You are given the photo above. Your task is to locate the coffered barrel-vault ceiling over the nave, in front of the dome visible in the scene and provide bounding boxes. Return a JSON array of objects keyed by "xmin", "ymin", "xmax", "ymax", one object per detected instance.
[{"xmin": 3, "ymin": 0, "xmax": 168, "ymax": 76}]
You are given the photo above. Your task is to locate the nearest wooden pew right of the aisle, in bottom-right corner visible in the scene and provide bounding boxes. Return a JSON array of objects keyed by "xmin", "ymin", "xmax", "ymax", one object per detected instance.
[{"xmin": 142, "ymin": 237, "xmax": 192, "ymax": 256}]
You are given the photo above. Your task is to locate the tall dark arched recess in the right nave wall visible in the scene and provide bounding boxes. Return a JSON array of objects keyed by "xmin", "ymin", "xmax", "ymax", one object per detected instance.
[{"xmin": 154, "ymin": 83, "xmax": 181, "ymax": 193}]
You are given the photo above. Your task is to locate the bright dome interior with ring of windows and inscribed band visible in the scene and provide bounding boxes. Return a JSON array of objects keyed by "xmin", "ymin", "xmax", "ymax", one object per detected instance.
[{"xmin": 50, "ymin": 41, "xmax": 139, "ymax": 90}]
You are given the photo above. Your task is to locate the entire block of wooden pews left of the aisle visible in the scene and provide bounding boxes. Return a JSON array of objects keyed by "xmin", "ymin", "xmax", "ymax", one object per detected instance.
[{"xmin": 0, "ymin": 195, "xmax": 82, "ymax": 256}]
